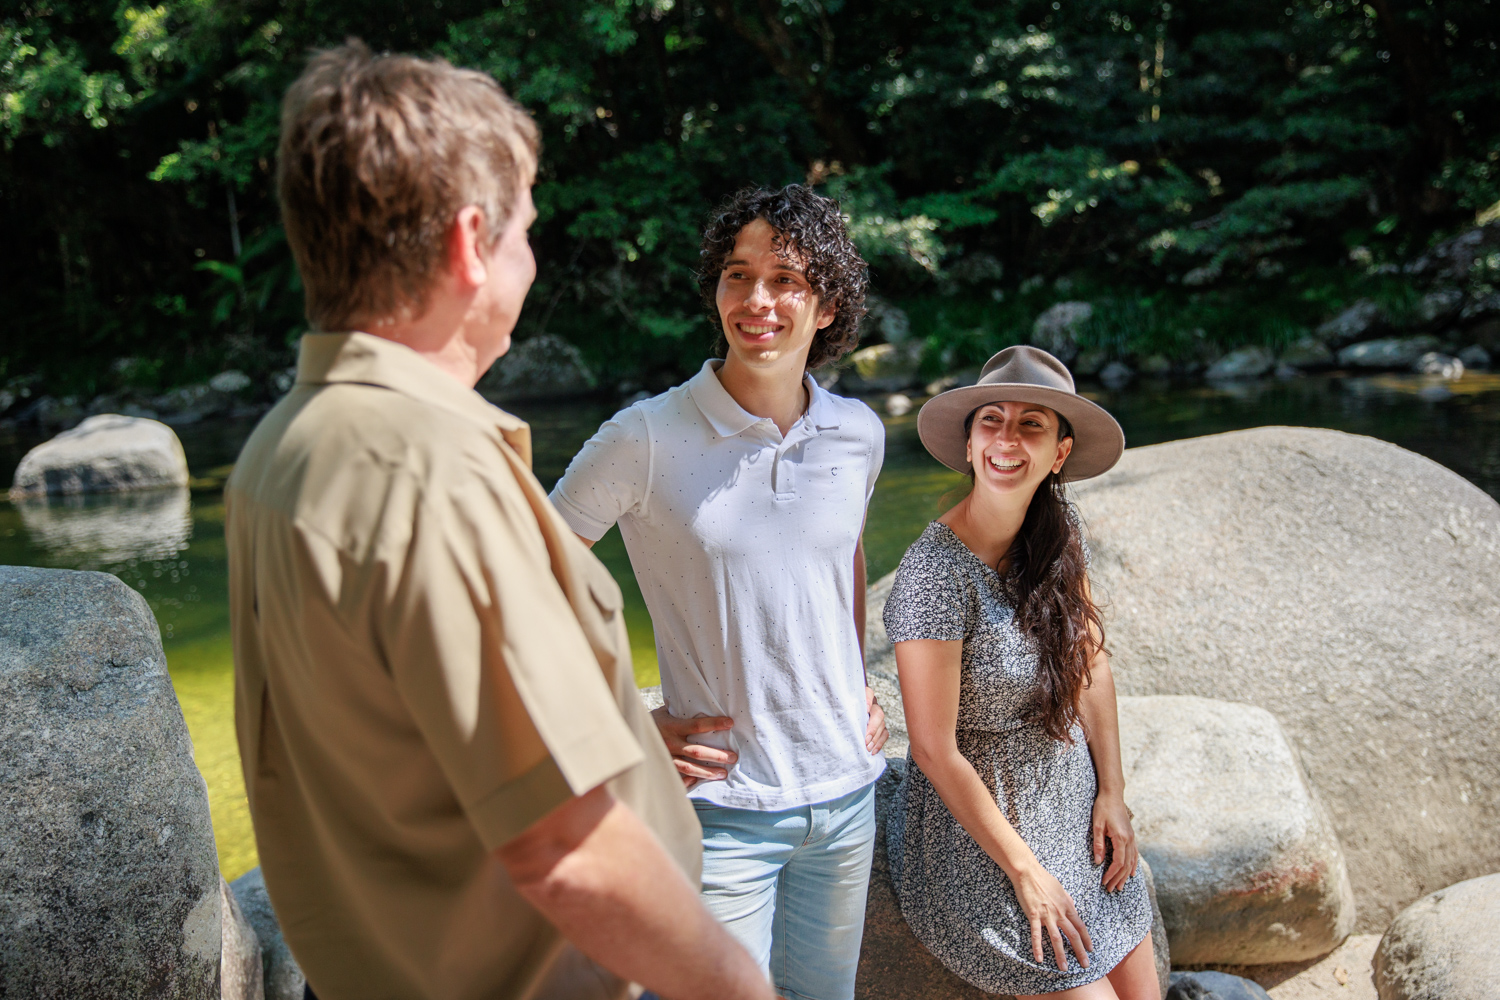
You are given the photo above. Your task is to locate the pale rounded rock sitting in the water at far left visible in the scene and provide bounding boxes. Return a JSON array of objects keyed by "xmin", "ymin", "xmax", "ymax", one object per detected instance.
[{"xmin": 11, "ymin": 414, "xmax": 188, "ymax": 498}]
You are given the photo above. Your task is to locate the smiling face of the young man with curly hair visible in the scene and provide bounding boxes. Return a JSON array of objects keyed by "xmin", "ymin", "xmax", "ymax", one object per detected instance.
[{"xmin": 714, "ymin": 219, "xmax": 837, "ymax": 370}]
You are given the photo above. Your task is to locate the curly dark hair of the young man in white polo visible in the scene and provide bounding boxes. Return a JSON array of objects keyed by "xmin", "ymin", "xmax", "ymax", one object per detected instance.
[{"xmin": 698, "ymin": 184, "xmax": 870, "ymax": 370}]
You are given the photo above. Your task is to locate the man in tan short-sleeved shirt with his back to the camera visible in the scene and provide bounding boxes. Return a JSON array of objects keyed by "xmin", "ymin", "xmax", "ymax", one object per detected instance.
[{"xmin": 225, "ymin": 40, "xmax": 771, "ymax": 1000}]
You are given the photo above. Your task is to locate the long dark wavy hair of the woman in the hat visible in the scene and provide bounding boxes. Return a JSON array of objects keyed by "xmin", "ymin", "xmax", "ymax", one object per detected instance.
[{"xmin": 963, "ymin": 409, "xmax": 1109, "ymax": 742}]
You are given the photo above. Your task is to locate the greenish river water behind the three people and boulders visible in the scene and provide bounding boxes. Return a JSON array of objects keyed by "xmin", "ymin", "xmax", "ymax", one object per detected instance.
[{"xmin": 0, "ymin": 373, "xmax": 1500, "ymax": 879}]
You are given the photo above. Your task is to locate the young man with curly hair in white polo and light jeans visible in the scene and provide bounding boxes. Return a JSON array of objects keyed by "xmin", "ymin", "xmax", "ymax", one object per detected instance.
[{"xmin": 552, "ymin": 184, "xmax": 885, "ymax": 1000}]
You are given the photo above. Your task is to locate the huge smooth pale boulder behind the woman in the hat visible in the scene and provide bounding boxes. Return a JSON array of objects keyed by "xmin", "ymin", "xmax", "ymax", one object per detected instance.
[{"xmin": 1071, "ymin": 427, "xmax": 1500, "ymax": 931}]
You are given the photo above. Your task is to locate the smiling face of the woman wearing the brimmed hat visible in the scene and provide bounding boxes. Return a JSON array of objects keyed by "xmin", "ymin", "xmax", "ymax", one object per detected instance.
[{"xmin": 968, "ymin": 403, "xmax": 1073, "ymax": 501}]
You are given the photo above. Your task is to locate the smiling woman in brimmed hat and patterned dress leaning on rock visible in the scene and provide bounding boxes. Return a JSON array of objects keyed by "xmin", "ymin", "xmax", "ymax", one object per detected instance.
[{"xmin": 885, "ymin": 346, "xmax": 1158, "ymax": 1000}]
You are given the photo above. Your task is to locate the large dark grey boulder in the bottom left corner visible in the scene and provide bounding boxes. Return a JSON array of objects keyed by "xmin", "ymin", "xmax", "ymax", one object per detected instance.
[{"xmin": 0, "ymin": 567, "xmax": 222, "ymax": 1000}]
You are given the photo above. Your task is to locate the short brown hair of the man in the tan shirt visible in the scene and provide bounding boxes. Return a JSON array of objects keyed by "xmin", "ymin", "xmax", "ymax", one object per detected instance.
[{"xmin": 276, "ymin": 39, "xmax": 539, "ymax": 331}]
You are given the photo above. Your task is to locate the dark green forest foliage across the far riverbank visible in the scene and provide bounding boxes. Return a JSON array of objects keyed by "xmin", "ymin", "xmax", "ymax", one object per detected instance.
[{"xmin": 0, "ymin": 0, "xmax": 1500, "ymax": 393}]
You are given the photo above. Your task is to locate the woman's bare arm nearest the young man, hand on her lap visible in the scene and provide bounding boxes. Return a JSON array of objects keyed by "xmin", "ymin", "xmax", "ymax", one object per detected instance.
[{"xmin": 896, "ymin": 639, "xmax": 1094, "ymax": 969}]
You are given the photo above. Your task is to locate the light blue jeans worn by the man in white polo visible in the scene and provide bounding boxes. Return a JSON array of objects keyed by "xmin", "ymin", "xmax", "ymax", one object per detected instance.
[{"xmin": 693, "ymin": 784, "xmax": 875, "ymax": 1000}]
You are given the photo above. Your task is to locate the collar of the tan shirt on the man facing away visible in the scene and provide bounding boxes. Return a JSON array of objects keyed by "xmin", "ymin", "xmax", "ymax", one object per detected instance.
[{"xmin": 297, "ymin": 333, "xmax": 534, "ymax": 468}]
